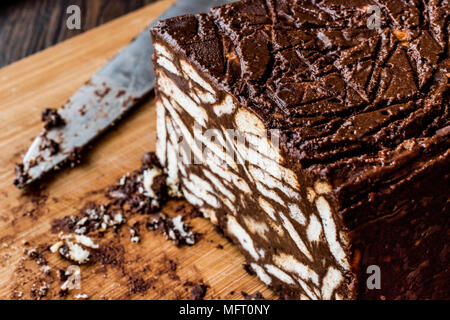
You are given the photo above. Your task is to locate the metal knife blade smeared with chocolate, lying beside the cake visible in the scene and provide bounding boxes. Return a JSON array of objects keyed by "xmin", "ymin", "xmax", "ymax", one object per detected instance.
[{"xmin": 14, "ymin": 0, "xmax": 235, "ymax": 189}]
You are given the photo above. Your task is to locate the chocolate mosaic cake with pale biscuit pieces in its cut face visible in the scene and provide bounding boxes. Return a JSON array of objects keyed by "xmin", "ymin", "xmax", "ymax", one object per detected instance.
[{"xmin": 152, "ymin": 0, "xmax": 450, "ymax": 299}]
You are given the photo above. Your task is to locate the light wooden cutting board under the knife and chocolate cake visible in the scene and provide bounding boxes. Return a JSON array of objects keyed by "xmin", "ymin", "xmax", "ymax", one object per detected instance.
[{"xmin": 0, "ymin": 0, "xmax": 274, "ymax": 299}]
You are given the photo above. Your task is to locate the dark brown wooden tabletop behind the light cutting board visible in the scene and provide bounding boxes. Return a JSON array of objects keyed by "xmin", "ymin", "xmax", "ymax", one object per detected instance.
[{"xmin": 0, "ymin": 0, "xmax": 157, "ymax": 68}]
